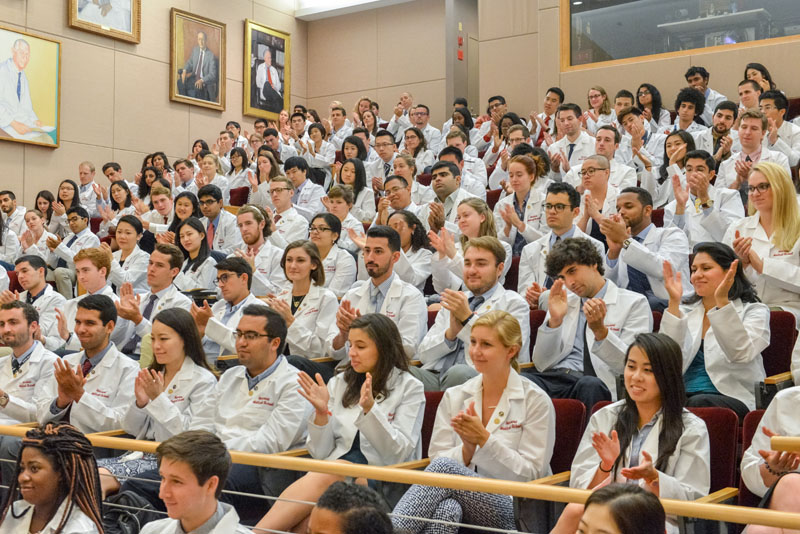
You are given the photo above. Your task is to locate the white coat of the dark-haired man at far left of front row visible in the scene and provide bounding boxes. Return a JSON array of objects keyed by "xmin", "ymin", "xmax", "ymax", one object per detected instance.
[{"xmin": 0, "ymin": 341, "xmax": 58, "ymax": 425}]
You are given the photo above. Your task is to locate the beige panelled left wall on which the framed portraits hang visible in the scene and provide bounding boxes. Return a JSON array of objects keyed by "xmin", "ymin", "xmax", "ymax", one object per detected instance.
[{"xmin": 0, "ymin": 0, "xmax": 308, "ymax": 205}]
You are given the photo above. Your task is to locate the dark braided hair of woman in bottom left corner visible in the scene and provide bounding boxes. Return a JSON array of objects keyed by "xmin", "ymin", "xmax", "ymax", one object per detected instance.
[{"xmin": 0, "ymin": 423, "xmax": 103, "ymax": 534}]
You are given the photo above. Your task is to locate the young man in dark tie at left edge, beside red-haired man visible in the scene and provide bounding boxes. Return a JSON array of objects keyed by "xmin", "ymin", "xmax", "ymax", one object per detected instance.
[{"xmin": 0, "ymin": 255, "xmax": 67, "ymax": 348}]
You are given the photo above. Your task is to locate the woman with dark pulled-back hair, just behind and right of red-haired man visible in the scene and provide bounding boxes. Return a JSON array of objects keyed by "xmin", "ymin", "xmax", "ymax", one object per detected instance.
[{"xmin": 106, "ymin": 215, "xmax": 150, "ymax": 293}]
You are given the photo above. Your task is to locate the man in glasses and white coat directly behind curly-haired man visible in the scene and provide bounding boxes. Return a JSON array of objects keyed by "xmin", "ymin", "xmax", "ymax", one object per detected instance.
[{"xmin": 517, "ymin": 182, "xmax": 606, "ymax": 310}]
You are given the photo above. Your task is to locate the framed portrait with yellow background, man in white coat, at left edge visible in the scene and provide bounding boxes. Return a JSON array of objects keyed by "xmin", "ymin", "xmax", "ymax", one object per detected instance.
[{"xmin": 0, "ymin": 26, "xmax": 61, "ymax": 148}]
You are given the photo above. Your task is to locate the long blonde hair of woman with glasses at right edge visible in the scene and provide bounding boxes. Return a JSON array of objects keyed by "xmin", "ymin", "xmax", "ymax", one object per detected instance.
[{"xmin": 748, "ymin": 161, "xmax": 800, "ymax": 250}]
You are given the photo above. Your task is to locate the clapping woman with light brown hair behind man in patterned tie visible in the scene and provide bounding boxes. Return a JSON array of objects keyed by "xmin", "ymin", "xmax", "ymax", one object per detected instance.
[{"xmin": 428, "ymin": 198, "xmax": 511, "ymax": 294}]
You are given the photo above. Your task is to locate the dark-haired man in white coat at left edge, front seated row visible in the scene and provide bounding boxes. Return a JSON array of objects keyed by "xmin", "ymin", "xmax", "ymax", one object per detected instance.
[{"xmin": 0, "ymin": 306, "xmax": 58, "ymax": 486}]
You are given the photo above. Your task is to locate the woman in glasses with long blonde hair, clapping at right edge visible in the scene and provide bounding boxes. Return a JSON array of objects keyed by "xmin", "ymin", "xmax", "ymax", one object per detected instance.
[{"xmin": 722, "ymin": 162, "xmax": 800, "ymax": 329}]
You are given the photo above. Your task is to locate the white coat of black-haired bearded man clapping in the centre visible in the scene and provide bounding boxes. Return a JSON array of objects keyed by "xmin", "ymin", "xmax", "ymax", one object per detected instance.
[{"xmin": 328, "ymin": 275, "xmax": 428, "ymax": 360}]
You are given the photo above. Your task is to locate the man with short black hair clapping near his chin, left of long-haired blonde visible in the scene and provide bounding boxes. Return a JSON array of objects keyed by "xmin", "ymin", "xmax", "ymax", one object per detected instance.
[{"xmin": 600, "ymin": 187, "xmax": 691, "ymax": 311}]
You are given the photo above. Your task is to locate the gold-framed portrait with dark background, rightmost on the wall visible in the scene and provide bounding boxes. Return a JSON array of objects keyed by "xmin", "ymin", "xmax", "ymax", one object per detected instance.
[{"xmin": 247, "ymin": 20, "xmax": 292, "ymax": 120}]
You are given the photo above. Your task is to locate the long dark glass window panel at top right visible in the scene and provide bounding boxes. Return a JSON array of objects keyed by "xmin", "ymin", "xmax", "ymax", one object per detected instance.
[{"xmin": 566, "ymin": 0, "xmax": 800, "ymax": 65}]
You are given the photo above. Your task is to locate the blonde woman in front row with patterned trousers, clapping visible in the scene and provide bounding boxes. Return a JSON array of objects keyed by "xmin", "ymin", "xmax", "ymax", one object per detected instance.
[{"xmin": 393, "ymin": 310, "xmax": 555, "ymax": 533}]
